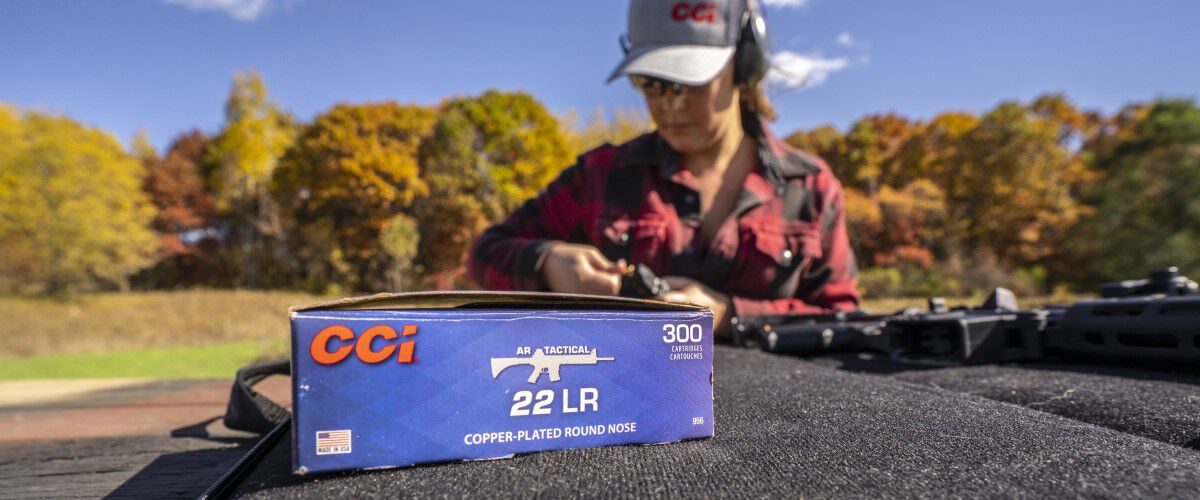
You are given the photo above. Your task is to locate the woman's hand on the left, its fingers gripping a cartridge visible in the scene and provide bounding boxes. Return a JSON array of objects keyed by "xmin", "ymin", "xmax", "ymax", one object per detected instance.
[{"xmin": 541, "ymin": 243, "xmax": 620, "ymax": 295}]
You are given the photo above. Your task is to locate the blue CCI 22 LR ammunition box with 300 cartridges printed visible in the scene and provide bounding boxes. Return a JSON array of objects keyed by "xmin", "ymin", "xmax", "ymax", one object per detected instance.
[{"xmin": 292, "ymin": 291, "xmax": 713, "ymax": 474}]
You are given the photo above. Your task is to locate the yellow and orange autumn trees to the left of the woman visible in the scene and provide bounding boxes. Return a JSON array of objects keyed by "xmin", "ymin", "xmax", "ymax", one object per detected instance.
[{"xmin": 0, "ymin": 72, "xmax": 649, "ymax": 295}]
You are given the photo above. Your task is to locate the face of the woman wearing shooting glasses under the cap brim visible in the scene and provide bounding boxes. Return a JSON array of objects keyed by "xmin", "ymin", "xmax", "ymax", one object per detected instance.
[{"xmin": 642, "ymin": 65, "xmax": 739, "ymax": 155}]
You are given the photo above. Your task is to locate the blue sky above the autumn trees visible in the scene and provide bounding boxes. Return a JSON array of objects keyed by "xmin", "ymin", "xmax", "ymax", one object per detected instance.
[{"xmin": 0, "ymin": 0, "xmax": 1200, "ymax": 147}]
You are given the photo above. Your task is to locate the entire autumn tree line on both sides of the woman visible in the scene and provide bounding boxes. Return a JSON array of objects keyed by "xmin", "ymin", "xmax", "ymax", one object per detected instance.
[{"xmin": 0, "ymin": 72, "xmax": 1200, "ymax": 296}]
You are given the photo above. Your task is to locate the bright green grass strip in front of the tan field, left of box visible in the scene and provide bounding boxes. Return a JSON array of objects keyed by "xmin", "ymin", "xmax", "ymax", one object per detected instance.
[{"xmin": 0, "ymin": 341, "xmax": 287, "ymax": 380}]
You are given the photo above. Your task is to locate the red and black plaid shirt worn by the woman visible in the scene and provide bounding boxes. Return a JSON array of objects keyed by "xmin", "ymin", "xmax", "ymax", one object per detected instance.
[{"xmin": 467, "ymin": 120, "xmax": 859, "ymax": 315}]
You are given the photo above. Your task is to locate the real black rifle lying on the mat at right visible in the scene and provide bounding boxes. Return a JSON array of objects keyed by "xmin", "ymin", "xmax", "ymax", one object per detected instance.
[{"xmin": 733, "ymin": 267, "xmax": 1200, "ymax": 367}]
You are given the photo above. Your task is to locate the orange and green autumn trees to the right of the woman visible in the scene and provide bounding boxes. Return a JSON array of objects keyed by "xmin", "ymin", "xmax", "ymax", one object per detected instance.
[{"xmin": 787, "ymin": 94, "xmax": 1200, "ymax": 295}]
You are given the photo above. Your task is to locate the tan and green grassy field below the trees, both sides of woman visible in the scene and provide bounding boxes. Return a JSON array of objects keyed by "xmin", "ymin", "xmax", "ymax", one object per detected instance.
[{"xmin": 0, "ymin": 290, "xmax": 1075, "ymax": 379}]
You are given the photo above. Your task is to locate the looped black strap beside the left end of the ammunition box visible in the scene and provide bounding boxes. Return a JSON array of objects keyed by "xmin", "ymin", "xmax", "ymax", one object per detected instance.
[{"xmin": 224, "ymin": 359, "xmax": 292, "ymax": 434}]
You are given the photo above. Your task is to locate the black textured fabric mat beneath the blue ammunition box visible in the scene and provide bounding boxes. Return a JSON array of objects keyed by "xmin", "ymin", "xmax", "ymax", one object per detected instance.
[{"xmin": 236, "ymin": 347, "xmax": 1200, "ymax": 498}]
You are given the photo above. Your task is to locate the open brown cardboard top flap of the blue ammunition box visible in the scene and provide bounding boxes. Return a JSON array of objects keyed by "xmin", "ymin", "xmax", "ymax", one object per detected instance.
[{"xmin": 288, "ymin": 290, "xmax": 706, "ymax": 313}]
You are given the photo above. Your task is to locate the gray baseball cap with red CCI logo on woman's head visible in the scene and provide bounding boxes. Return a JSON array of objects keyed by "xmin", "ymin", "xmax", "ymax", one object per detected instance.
[{"xmin": 608, "ymin": 0, "xmax": 751, "ymax": 85}]
